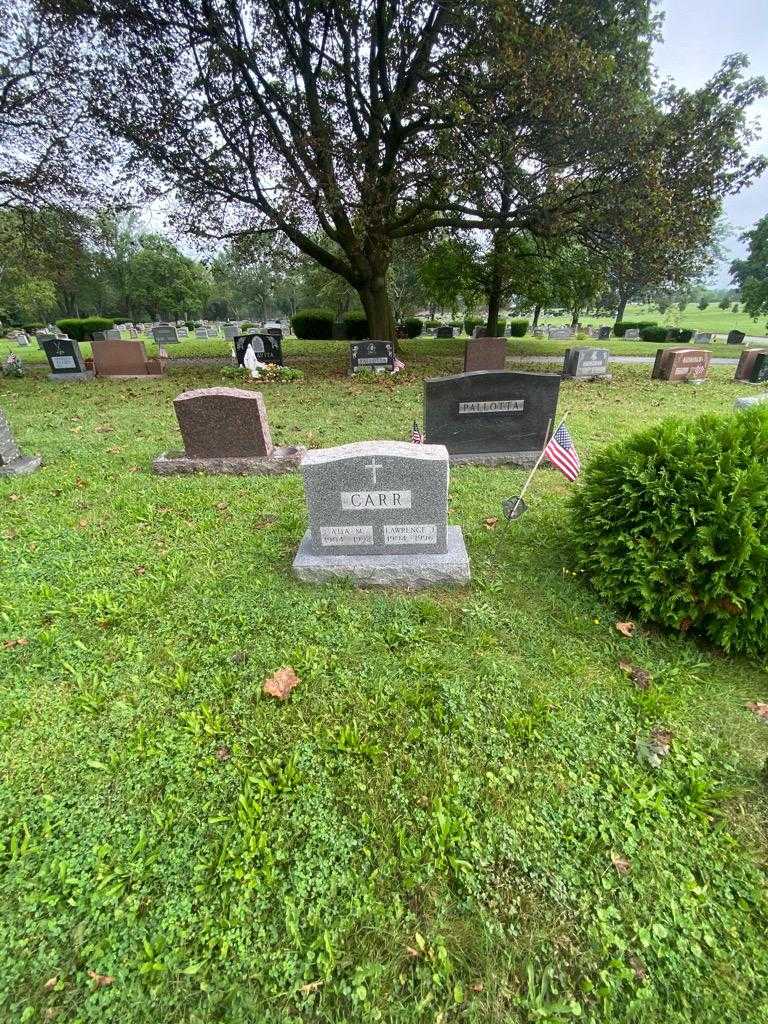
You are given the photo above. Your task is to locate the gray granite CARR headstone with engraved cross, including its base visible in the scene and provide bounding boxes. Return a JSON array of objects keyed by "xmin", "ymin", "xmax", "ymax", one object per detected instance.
[{"xmin": 294, "ymin": 441, "xmax": 469, "ymax": 589}]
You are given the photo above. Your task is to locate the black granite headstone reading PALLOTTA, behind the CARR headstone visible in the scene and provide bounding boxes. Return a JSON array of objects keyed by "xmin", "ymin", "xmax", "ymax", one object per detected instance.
[{"xmin": 424, "ymin": 370, "xmax": 560, "ymax": 466}]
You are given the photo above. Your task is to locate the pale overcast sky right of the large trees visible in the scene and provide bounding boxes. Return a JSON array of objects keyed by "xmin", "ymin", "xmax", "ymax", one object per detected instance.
[{"xmin": 655, "ymin": 0, "xmax": 768, "ymax": 285}]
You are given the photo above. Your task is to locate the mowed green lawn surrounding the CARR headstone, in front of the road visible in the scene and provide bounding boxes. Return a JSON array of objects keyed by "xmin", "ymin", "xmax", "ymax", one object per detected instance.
[{"xmin": 0, "ymin": 354, "xmax": 768, "ymax": 1024}]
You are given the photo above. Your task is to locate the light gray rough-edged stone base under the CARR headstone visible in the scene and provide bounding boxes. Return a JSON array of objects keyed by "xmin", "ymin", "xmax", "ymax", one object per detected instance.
[{"xmin": 293, "ymin": 526, "xmax": 470, "ymax": 590}]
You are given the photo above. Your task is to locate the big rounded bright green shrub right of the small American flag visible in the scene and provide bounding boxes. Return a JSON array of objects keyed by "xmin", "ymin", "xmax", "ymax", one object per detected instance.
[{"xmin": 572, "ymin": 407, "xmax": 768, "ymax": 657}]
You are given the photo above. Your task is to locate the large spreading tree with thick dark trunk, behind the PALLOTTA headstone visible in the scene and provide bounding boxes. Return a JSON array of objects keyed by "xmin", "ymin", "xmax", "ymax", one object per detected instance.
[{"xmin": 41, "ymin": 0, "xmax": 684, "ymax": 337}]
